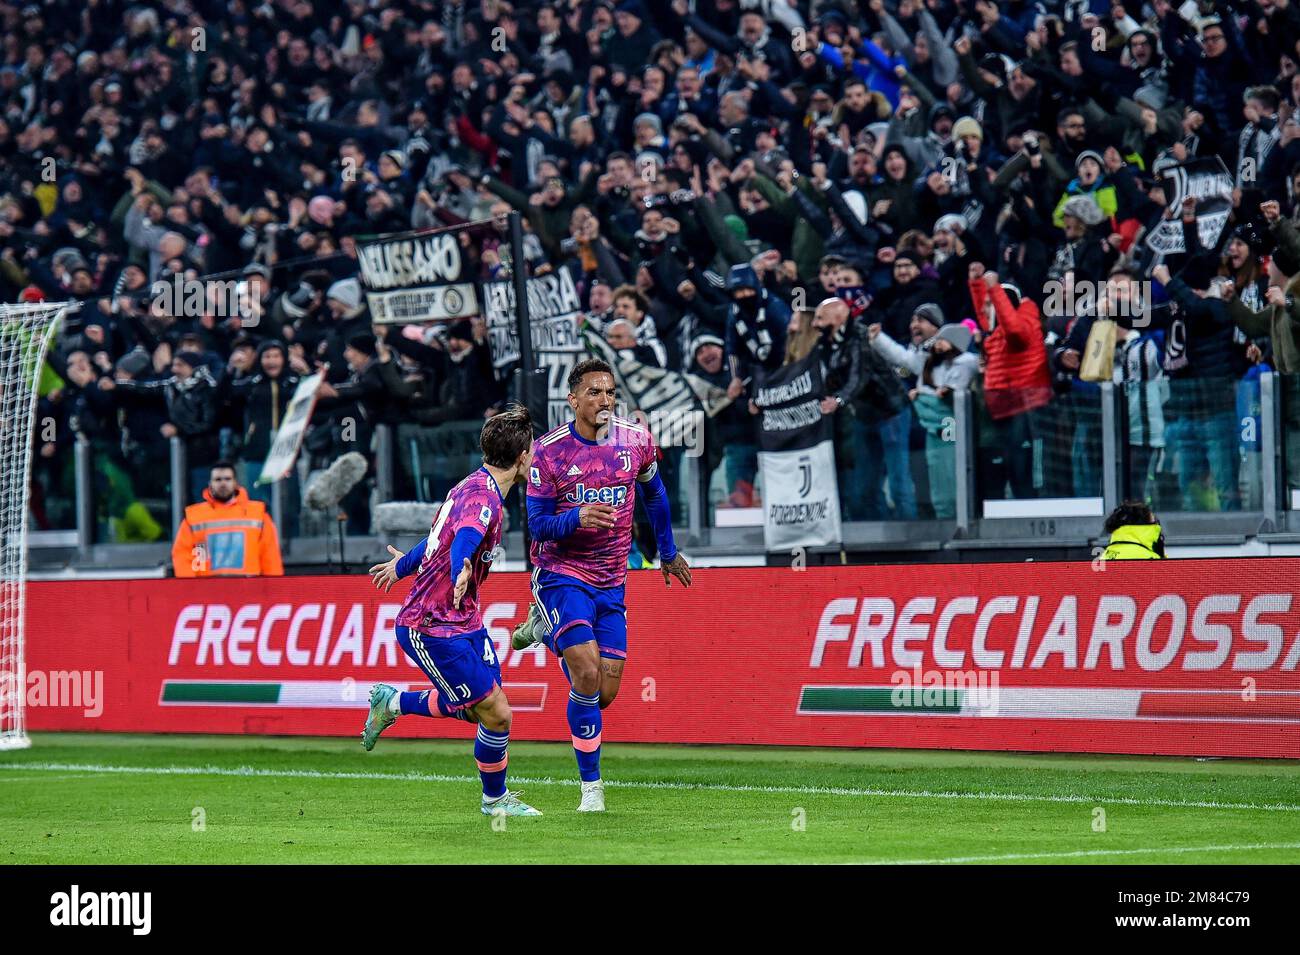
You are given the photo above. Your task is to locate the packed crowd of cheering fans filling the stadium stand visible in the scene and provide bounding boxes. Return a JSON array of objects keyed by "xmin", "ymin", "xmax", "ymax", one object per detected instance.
[{"xmin": 0, "ymin": 0, "xmax": 1300, "ymax": 539}]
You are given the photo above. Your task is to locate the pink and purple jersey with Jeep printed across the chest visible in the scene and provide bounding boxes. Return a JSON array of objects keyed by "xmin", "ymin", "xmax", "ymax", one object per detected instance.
[{"xmin": 528, "ymin": 418, "xmax": 659, "ymax": 587}]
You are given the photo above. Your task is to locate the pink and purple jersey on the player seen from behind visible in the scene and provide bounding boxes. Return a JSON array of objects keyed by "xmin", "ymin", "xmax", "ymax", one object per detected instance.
[{"xmin": 397, "ymin": 468, "xmax": 503, "ymax": 637}]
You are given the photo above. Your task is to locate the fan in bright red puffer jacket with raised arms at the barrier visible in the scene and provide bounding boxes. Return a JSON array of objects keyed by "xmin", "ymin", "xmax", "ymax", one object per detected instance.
[{"xmin": 970, "ymin": 262, "xmax": 1052, "ymax": 498}]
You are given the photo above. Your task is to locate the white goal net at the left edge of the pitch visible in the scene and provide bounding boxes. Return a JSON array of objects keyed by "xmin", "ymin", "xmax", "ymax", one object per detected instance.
[{"xmin": 0, "ymin": 303, "xmax": 77, "ymax": 750}]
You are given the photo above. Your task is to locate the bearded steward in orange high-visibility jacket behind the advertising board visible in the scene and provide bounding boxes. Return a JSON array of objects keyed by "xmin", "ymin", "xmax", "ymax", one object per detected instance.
[{"xmin": 172, "ymin": 461, "xmax": 285, "ymax": 577}]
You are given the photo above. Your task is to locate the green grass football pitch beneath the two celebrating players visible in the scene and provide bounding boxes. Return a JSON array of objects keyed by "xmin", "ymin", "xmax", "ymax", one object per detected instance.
[{"xmin": 0, "ymin": 734, "xmax": 1300, "ymax": 864}]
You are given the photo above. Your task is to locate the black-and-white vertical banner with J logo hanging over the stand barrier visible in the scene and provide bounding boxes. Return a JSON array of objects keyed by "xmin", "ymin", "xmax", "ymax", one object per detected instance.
[{"xmin": 754, "ymin": 352, "xmax": 844, "ymax": 551}]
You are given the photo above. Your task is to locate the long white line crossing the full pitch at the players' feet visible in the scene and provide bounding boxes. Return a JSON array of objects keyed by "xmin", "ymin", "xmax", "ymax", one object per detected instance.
[{"xmin": 0, "ymin": 763, "xmax": 1300, "ymax": 812}]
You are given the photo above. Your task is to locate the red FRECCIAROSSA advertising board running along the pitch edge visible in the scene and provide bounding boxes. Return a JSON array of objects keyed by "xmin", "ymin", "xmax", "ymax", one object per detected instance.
[{"xmin": 23, "ymin": 559, "xmax": 1300, "ymax": 758}]
